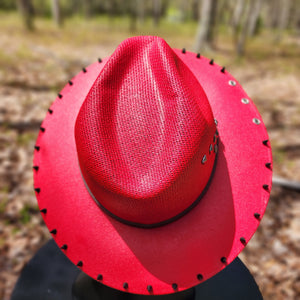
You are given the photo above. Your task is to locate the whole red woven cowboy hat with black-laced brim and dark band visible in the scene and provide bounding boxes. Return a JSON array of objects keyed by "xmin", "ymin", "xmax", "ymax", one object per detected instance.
[{"xmin": 34, "ymin": 36, "xmax": 272, "ymax": 295}]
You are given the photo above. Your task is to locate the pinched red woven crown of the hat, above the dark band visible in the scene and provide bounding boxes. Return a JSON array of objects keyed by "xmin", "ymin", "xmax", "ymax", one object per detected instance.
[{"xmin": 75, "ymin": 37, "xmax": 216, "ymax": 224}]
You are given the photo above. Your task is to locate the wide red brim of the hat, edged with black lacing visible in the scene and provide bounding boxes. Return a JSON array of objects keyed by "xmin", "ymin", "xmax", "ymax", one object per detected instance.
[{"xmin": 34, "ymin": 50, "xmax": 272, "ymax": 295}]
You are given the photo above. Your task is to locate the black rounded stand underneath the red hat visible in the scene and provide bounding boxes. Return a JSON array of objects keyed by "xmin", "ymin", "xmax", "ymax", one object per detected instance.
[{"xmin": 11, "ymin": 239, "xmax": 263, "ymax": 300}]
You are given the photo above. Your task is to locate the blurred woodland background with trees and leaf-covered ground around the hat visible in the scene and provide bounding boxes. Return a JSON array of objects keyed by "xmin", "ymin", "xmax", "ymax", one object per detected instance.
[{"xmin": 0, "ymin": 0, "xmax": 300, "ymax": 300}]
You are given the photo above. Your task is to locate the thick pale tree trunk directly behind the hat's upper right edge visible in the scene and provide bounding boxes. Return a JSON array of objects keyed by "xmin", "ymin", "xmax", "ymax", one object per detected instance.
[{"xmin": 195, "ymin": 0, "xmax": 217, "ymax": 52}]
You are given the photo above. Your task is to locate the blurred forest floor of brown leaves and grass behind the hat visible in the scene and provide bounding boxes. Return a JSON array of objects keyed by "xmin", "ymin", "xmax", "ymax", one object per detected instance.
[{"xmin": 0, "ymin": 14, "xmax": 300, "ymax": 300}]
